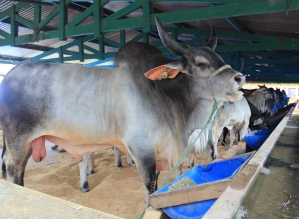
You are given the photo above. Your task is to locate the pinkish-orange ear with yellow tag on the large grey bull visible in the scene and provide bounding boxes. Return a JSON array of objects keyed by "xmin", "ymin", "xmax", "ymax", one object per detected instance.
[{"xmin": 144, "ymin": 65, "xmax": 180, "ymax": 80}]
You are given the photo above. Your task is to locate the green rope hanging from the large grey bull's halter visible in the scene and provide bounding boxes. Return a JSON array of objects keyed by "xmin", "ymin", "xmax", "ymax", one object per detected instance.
[{"xmin": 134, "ymin": 101, "xmax": 218, "ymax": 219}]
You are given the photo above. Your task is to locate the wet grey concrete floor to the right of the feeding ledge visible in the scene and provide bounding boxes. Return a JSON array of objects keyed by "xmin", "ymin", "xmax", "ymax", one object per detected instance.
[{"xmin": 235, "ymin": 108, "xmax": 299, "ymax": 219}]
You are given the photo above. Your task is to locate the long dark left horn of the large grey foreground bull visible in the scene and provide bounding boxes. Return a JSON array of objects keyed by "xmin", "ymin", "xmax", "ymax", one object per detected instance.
[{"xmin": 155, "ymin": 18, "xmax": 188, "ymax": 56}]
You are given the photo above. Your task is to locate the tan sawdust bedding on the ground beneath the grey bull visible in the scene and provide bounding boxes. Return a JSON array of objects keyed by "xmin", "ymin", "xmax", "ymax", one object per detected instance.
[{"xmin": 0, "ymin": 133, "xmax": 229, "ymax": 219}]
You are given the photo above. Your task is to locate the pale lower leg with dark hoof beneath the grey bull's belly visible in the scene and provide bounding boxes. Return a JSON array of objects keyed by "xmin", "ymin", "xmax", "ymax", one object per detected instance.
[{"xmin": 79, "ymin": 153, "xmax": 94, "ymax": 192}]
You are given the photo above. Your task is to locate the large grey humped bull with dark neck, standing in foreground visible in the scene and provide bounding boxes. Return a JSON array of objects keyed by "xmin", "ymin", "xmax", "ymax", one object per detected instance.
[{"xmin": 0, "ymin": 20, "xmax": 245, "ymax": 203}]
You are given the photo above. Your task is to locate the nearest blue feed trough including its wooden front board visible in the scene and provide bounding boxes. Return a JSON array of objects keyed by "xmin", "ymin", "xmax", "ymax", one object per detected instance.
[{"xmin": 150, "ymin": 153, "xmax": 252, "ymax": 219}]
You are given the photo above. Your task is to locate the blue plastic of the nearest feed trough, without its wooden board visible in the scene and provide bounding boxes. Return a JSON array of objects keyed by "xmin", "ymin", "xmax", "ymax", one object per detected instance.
[{"xmin": 155, "ymin": 154, "xmax": 251, "ymax": 219}]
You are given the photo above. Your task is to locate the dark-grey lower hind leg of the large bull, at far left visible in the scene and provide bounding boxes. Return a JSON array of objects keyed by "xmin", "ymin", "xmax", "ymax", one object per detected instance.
[{"xmin": 4, "ymin": 137, "xmax": 32, "ymax": 186}]
